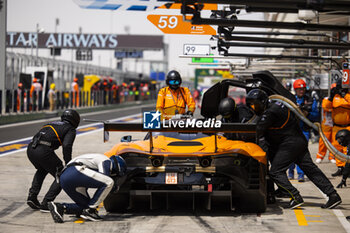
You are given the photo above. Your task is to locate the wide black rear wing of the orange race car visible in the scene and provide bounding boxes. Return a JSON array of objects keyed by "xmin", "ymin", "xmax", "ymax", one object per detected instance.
[{"xmin": 103, "ymin": 122, "xmax": 259, "ymax": 152}]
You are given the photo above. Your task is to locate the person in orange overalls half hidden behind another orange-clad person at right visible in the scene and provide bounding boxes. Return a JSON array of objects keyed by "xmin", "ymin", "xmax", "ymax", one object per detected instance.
[{"xmin": 316, "ymin": 83, "xmax": 336, "ymax": 163}]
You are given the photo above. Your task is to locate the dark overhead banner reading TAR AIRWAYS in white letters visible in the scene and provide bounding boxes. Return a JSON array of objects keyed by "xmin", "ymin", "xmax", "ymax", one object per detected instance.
[{"xmin": 6, "ymin": 32, "xmax": 163, "ymax": 50}]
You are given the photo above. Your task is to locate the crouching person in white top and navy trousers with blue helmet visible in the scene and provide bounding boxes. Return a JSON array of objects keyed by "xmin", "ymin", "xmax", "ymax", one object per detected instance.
[{"xmin": 49, "ymin": 154, "xmax": 126, "ymax": 223}]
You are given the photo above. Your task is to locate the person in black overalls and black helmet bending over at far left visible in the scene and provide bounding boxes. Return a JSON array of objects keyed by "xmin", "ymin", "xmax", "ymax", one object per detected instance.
[{"xmin": 27, "ymin": 109, "xmax": 80, "ymax": 212}]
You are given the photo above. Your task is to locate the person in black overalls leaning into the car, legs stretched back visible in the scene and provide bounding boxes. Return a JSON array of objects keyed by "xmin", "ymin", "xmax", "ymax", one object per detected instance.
[{"xmin": 246, "ymin": 89, "xmax": 341, "ymax": 209}]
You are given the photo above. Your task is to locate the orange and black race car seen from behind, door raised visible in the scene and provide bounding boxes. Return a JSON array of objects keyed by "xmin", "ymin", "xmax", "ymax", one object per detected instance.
[{"xmin": 104, "ymin": 72, "xmax": 292, "ymax": 213}]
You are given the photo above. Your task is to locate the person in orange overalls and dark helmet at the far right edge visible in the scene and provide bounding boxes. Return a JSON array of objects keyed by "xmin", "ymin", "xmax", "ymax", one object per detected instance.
[{"xmin": 325, "ymin": 79, "xmax": 350, "ymax": 176}]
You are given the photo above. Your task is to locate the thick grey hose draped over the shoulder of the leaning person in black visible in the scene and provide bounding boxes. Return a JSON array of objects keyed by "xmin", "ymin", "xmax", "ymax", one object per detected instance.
[{"xmin": 269, "ymin": 95, "xmax": 350, "ymax": 163}]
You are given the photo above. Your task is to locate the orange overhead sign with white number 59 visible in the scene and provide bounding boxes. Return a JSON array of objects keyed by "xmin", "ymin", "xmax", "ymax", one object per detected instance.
[{"xmin": 147, "ymin": 15, "xmax": 216, "ymax": 35}]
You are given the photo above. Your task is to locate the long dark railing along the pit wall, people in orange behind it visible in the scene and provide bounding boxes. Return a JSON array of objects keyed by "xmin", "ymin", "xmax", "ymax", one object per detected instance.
[{"xmin": 0, "ymin": 90, "xmax": 157, "ymax": 115}]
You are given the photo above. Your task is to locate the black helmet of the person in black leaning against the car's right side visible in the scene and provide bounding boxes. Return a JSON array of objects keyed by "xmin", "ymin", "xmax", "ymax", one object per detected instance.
[{"xmin": 246, "ymin": 89, "xmax": 268, "ymax": 115}]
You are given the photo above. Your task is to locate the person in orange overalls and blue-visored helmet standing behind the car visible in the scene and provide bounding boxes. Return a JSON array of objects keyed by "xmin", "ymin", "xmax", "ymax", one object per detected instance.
[{"xmin": 156, "ymin": 70, "xmax": 196, "ymax": 119}]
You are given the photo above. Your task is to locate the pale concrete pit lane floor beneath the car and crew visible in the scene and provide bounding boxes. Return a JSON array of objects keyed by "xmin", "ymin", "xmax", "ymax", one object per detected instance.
[{"xmin": 0, "ymin": 116, "xmax": 350, "ymax": 233}]
